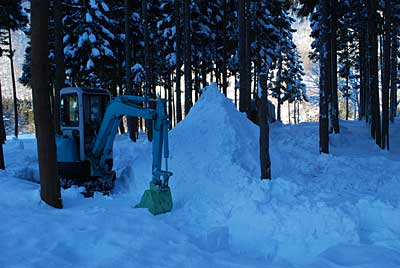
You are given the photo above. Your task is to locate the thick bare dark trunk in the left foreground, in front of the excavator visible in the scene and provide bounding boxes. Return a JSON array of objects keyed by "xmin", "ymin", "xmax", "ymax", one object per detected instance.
[{"xmin": 31, "ymin": 0, "xmax": 62, "ymax": 208}]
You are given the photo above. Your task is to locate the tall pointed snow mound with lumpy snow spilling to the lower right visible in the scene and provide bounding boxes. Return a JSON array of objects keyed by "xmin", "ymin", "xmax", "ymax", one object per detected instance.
[{"xmin": 162, "ymin": 84, "xmax": 358, "ymax": 261}]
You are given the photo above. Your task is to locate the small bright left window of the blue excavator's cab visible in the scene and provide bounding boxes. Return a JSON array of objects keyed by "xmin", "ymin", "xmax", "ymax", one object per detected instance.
[{"xmin": 60, "ymin": 93, "xmax": 79, "ymax": 127}]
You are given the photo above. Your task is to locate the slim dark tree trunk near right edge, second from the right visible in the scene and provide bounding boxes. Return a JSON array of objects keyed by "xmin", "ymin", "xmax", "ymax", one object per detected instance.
[{"xmin": 381, "ymin": 0, "xmax": 392, "ymax": 150}]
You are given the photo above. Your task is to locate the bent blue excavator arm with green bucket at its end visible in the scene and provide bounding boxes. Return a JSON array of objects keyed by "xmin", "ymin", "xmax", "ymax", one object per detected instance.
[{"xmin": 90, "ymin": 95, "xmax": 172, "ymax": 214}]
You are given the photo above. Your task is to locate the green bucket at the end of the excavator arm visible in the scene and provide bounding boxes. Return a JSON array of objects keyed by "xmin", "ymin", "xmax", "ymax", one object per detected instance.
[{"xmin": 135, "ymin": 182, "xmax": 172, "ymax": 215}]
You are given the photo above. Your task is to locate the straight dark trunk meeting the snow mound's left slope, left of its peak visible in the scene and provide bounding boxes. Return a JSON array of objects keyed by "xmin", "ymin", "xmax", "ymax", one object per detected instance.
[{"xmin": 184, "ymin": 0, "xmax": 193, "ymax": 116}]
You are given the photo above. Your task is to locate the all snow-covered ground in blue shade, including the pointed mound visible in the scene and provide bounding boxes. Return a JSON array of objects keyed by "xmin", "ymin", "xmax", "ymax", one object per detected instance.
[{"xmin": 0, "ymin": 87, "xmax": 400, "ymax": 268}]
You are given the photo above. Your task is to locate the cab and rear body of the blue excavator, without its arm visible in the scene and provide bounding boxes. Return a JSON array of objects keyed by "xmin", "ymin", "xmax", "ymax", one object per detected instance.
[{"xmin": 57, "ymin": 88, "xmax": 113, "ymax": 186}]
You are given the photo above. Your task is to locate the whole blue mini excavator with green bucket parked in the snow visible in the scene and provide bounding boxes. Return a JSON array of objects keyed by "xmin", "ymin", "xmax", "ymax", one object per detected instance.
[{"xmin": 56, "ymin": 87, "xmax": 172, "ymax": 215}]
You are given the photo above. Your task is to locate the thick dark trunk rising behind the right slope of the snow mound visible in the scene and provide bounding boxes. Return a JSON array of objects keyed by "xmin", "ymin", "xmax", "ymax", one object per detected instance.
[{"xmin": 238, "ymin": 0, "xmax": 250, "ymax": 113}]
